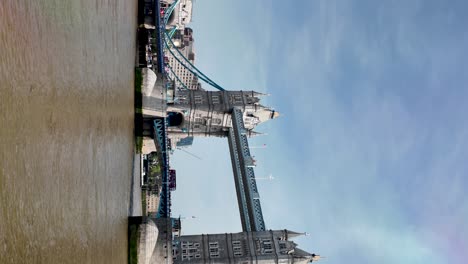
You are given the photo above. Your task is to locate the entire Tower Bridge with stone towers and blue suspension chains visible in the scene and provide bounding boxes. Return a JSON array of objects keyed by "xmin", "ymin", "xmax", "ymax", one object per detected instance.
[{"xmin": 137, "ymin": 0, "xmax": 320, "ymax": 264}]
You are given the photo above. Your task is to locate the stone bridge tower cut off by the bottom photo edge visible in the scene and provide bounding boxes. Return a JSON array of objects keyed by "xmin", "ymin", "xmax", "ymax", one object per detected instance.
[{"xmin": 172, "ymin": 230, "xmax": 320, "ymax": 264}]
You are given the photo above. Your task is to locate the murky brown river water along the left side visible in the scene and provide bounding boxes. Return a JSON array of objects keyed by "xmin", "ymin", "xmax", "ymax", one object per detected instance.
[{"xmin": 0, "ymin": 0, "xmax": 137, "ymax": 264}]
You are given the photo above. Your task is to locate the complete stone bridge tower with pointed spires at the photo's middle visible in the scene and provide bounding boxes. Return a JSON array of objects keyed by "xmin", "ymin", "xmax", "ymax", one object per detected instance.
[{"xmin": 167, "ymin": 89, "xmax": 279, "ymax": 145}]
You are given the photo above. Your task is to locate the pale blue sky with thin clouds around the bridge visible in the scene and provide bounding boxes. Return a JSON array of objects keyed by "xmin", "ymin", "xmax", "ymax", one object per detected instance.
[{"xmin": 172, "ymin": 0, "xmax": 468, "ymax": 264}]
